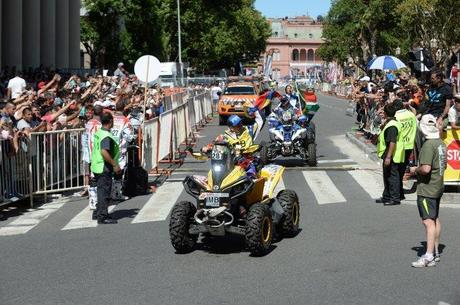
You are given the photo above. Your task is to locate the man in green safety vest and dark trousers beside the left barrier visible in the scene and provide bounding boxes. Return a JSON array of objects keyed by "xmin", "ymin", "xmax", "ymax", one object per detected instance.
[{"xmin": 91, "ymin": 112, "xmax": 121, "ymax": 224}]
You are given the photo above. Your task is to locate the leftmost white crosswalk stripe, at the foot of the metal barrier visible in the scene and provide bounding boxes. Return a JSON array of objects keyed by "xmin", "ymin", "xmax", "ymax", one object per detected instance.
[{"xmin": 0, "ymin": 201, "xmax": 68, "ymax": 236}]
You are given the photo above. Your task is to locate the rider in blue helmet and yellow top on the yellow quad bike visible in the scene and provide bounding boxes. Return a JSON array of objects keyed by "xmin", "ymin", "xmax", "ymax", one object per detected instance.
[{"xmin": 201, "ymin": 114, "xmax": 258, "ymax": 178}]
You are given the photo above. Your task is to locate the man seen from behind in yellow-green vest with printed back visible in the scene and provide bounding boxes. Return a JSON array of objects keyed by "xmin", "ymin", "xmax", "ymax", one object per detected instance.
[{"xmin": 393, "ymin": 99, "xmax": 417, "ymax": 200}]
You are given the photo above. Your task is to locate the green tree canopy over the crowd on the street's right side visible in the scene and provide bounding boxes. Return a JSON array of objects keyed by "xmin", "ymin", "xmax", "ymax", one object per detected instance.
[{"xmin": 318, "ymin": 0, "xmax": 460, "ymax": 66}]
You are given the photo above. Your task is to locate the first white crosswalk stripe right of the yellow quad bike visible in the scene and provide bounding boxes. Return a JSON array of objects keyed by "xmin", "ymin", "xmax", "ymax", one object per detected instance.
[{"xmin": 302, "ymin": 171, "xmax": 347, "ymax": 204}]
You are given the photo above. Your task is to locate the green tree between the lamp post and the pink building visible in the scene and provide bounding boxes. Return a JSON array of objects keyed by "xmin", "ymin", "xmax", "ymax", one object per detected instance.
[{"xmin": 161, "ymin": 0, "xmax": 271, "ymax": 71}]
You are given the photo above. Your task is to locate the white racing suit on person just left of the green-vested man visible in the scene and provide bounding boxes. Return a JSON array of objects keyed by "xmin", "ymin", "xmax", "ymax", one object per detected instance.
[{"xmin": 81, "ymin": 118, "xmax": 102, "ymax": 210}]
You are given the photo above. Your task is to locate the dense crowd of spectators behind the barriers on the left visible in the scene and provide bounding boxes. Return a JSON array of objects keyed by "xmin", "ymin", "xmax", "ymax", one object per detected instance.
[{"xmin": 0, "ymin": 63, "xmax": 171, "ymax": 151}]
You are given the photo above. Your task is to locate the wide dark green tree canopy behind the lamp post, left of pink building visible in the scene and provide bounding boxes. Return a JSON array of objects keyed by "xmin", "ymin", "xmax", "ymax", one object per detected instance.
[{"xmin": 82, "ymin": 0, "xmax": 270, "ymax": 71}]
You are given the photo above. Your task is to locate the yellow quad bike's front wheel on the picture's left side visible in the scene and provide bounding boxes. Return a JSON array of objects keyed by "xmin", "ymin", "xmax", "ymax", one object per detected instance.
[{"xmin": 169, "ymin": 201, "xmax": 198, "ymax": 253}]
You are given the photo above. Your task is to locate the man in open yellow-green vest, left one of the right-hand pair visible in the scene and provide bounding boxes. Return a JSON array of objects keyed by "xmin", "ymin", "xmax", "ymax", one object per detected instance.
[{"xmin": 376, "ymin": 104, "xmax": 404, "ymax": 206}]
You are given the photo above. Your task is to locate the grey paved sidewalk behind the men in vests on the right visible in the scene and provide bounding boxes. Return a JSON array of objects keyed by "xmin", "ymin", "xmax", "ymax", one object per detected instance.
[{"xmin": 345, "ymin": 130, "xmax": 460, "ymax": 203}]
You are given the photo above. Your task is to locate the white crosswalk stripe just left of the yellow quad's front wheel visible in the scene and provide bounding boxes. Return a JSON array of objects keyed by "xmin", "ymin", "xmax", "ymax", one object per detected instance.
[{"xmin": 132, "ymin": 182, "xmax": 183, "ymax": 223}]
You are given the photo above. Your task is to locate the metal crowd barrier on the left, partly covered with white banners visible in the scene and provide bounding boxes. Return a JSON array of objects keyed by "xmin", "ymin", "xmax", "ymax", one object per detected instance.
[{"xmin": 0, "ymin": 90, "xmax": 212, "ymax": 207}]
